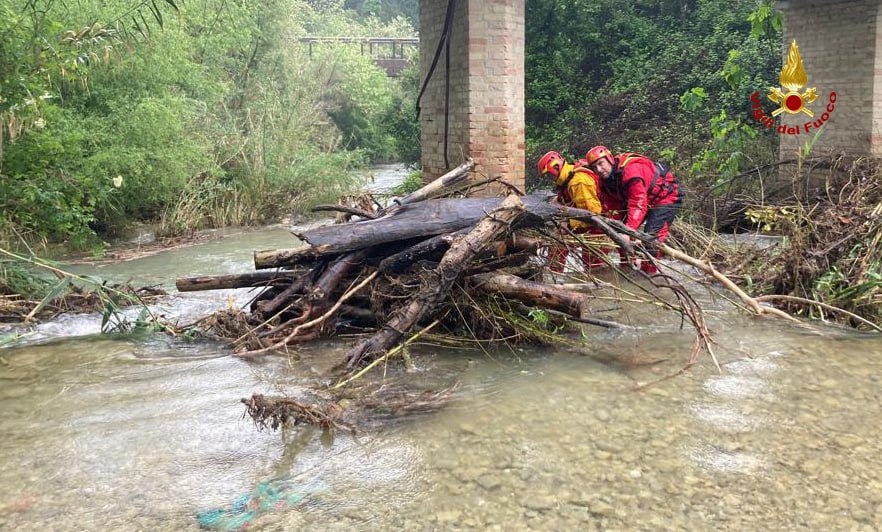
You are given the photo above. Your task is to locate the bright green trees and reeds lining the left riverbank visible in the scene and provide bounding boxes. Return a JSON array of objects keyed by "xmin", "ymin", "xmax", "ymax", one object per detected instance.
[{"xmin": 0, "ymin": 0, "xmax": 416, "ymax": 250}]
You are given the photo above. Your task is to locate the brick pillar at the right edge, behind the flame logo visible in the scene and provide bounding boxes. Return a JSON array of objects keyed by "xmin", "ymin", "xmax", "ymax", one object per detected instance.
[{"xmin": 772, "ymin": 0, "xmax": 882, "ymax": 159}]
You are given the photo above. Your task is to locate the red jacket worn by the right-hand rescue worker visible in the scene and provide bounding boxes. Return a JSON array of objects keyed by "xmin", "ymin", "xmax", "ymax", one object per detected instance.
[{"xmin": 600, "ymin": 153, "xmax": 680, "ymax": 229}]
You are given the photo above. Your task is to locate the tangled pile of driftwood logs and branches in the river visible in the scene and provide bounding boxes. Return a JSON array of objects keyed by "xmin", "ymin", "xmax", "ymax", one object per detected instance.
[{"xmin": 177, "ymin": 161, "xmax": 680, "ymax": 372}]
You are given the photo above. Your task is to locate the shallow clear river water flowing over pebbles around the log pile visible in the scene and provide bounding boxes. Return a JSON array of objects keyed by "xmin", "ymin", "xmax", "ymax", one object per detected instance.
[{"xmin": 0, "ymin": 164, "xmax": 882, "ymax": 530}]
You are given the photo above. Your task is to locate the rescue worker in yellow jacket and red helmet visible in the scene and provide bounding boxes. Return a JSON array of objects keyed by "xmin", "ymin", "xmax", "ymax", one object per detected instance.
[{"xmin": 538, "ymin": 151, "xmax": 605, "ymax": 272}]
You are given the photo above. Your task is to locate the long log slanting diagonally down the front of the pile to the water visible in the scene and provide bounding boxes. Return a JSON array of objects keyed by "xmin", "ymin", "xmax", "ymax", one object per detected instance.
[{"xmin": 346, "ymin": 194, "xmax": 524, "ymax": 370}]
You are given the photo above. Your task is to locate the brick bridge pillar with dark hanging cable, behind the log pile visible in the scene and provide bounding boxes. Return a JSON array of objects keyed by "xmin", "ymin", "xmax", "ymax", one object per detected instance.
[{"xmin": 420, "ymin": 0, "xmax": 524, "ymax": 194}]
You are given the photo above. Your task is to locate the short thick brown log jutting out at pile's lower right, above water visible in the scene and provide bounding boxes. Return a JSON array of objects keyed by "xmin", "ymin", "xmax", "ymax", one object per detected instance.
[{"xmin": 467, "ymin": 272, "xmax": 587, "ymax": 318}]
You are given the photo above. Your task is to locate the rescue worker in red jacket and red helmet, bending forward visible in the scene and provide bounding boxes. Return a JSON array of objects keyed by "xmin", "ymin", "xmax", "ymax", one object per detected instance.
[{"xmin": 585, "ymin": 146, "xmax": 683, "ymax": 275}]
